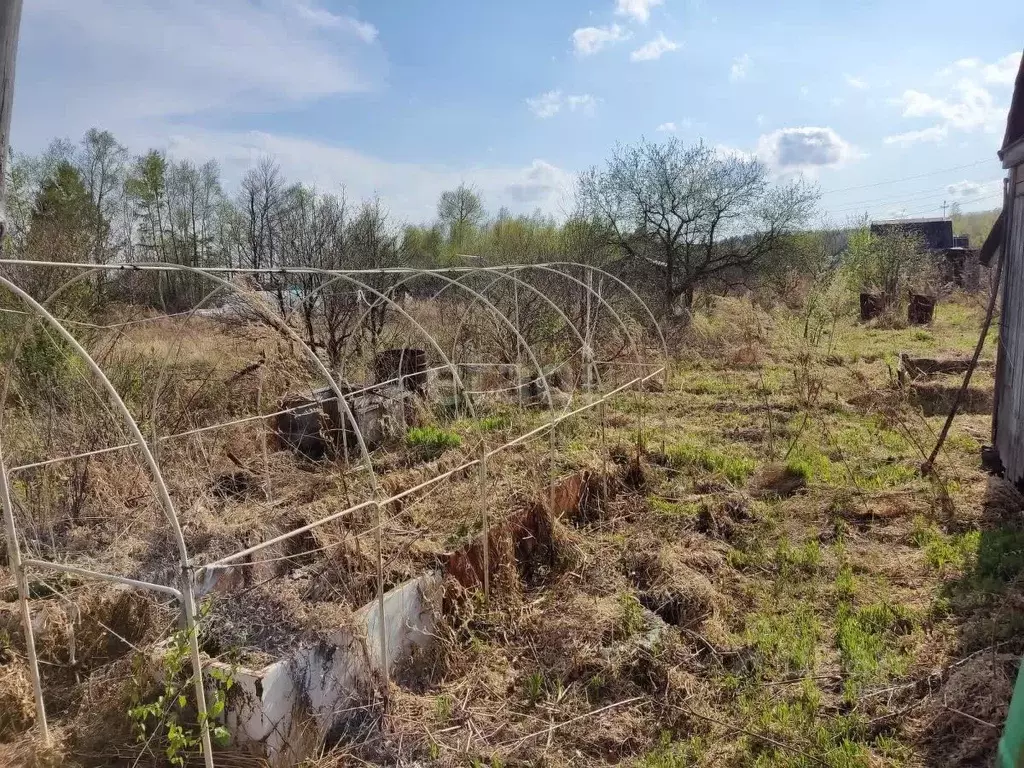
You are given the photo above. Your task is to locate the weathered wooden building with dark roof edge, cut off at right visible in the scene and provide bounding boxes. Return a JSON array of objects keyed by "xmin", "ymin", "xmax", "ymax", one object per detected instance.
[{"xmin": 981, "ymin": 54, "xmax": 1024, "ymax": 487}]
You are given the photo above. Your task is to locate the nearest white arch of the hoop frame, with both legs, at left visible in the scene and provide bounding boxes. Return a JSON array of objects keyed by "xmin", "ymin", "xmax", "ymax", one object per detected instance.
[{"xmin": 0, "ymin": 274, "xmax": 213, "ymax": 768}]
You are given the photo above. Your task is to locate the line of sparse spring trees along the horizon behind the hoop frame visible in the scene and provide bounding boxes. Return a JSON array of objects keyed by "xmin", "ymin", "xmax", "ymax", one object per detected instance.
[{"xmin": 4, "ymin": 129, "xmax": 847, "ymax": 324}]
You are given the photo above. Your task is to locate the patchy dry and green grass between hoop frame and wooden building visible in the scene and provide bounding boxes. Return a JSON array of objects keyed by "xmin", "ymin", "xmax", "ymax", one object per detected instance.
[{"xmin": 364, "ymin": 301, "xmax": 1024, "ymax": 768}]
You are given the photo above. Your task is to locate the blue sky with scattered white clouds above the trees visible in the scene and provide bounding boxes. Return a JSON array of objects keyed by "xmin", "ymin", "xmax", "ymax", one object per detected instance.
[{"xmin": 11, "ymin": 0, "xmax": 1024, "ymax": 228}]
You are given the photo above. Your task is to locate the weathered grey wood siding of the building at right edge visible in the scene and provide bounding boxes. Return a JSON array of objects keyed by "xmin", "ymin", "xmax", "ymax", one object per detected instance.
[{"xmin": 995, "ymin": 165, "xmax": 1024, "ymax": 482}]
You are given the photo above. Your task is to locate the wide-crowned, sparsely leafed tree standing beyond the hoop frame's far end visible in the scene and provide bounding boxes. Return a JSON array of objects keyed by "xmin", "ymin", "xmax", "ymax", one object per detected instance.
[{"xmin": 578, "ymin": 138, "xmax": 817, "ymax": 311}]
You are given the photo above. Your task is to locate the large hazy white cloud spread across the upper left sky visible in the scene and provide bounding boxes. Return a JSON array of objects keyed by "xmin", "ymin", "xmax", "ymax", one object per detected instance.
[{"xmin": 18, "ymin": 0, "xmax": 379, "ymax": 135}]
